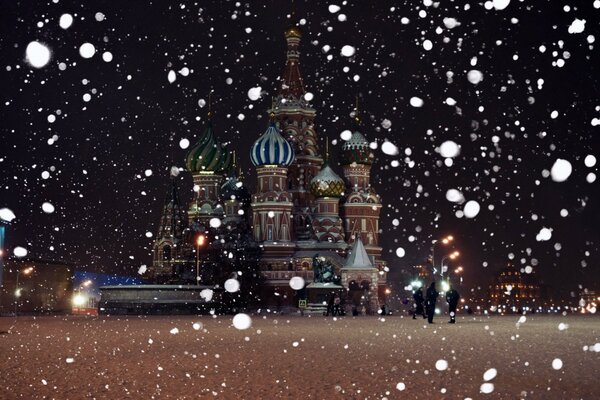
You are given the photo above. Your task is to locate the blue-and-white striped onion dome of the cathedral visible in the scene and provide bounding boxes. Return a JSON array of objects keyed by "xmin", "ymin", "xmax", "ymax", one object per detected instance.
[{"xmin": 250, "ymin": 122, "xmax": 294, "ymax": 167}]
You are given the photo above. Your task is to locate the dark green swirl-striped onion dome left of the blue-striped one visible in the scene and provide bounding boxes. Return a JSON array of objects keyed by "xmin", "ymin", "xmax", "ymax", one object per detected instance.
[{"xmin": 186, "ymin": 120, "xmax": 233, "ymax": 172}]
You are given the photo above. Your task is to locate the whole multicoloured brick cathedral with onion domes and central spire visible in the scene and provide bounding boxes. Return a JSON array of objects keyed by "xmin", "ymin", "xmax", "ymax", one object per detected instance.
[{"xmin": 148, "ymin": 27, "xmax": 387, "ymax": 310}]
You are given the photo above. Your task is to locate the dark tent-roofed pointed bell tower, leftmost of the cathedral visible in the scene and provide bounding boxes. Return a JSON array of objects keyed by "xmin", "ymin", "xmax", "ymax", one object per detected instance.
[{"xmin": 149, "ymin": 177, "xmax": 187, "ymax": 282}]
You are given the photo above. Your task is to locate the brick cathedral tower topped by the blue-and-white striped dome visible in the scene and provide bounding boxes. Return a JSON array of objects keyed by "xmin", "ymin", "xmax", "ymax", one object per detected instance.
[{"xmin": 250, "ymin": 114, "xmax": 295, "ymax": 270}]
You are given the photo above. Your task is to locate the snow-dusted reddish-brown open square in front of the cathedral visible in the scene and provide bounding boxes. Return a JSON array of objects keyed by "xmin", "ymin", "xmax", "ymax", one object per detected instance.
[{"xmin": 0, "ymin": 315, "xmax": 600, "ymax": 399}]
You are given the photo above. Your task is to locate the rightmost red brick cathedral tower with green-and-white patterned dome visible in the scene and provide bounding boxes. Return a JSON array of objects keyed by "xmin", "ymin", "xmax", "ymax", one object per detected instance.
[{"xmin": 342, "ymin": 101, "xmax": 383, "ymax": 267}]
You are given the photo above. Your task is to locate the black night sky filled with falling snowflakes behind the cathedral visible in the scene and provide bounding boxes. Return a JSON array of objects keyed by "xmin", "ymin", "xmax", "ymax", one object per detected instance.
[{"xmin": 0, "ymin": 0, "xmax": 600, "ymax": 291}]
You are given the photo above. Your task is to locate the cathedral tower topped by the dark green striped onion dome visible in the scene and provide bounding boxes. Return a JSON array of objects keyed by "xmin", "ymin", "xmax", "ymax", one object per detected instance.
[{"xmin": 186, "ymin": 106, "xmax": 233, "ymax": 225}]
